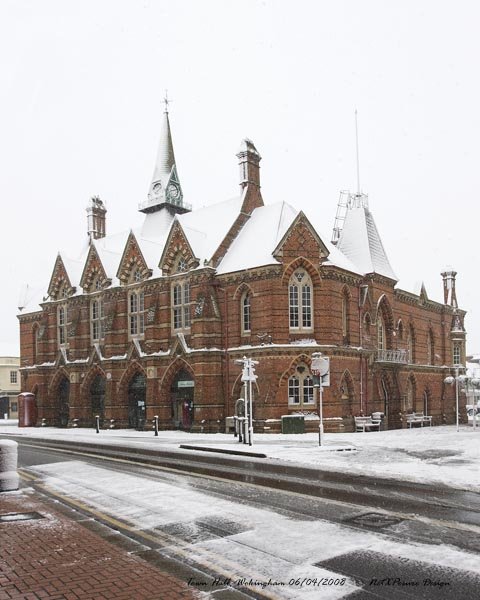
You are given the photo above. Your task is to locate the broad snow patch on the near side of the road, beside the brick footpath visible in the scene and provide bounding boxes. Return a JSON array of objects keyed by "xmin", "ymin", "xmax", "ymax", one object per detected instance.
[{"xmin": 29, "ymin": 460, "xmax": 480, "ymax": 600}]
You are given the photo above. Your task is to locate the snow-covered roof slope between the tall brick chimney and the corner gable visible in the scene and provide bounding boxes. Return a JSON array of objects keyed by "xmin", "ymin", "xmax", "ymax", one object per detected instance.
[{"xmin": 217, "ymin": 202, "xmax": 298, "ymax": 274}]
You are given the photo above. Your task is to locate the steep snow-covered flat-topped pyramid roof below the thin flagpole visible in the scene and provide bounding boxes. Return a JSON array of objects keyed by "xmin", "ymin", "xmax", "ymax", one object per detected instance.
[{"xmin": 337, "ymin": 206, "xmax": 397, "ymax": 281}]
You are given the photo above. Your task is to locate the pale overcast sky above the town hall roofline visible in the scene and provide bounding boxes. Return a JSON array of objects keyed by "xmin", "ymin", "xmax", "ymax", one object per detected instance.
[{"xmin": 0, "ymin": 0, "xmax": 480, "ymax": 352}]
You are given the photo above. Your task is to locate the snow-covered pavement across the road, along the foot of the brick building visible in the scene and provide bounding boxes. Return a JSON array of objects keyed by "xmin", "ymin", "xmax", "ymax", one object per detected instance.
[{"xmin": 0, "ymin": 421, "xmax": 480, "ymax": 492}]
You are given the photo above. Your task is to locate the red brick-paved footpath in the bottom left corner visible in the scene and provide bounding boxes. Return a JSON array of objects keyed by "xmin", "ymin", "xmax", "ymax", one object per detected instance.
[{"xmin": 0, "ymin": 490, "xmax": 203, "ymax": 600}]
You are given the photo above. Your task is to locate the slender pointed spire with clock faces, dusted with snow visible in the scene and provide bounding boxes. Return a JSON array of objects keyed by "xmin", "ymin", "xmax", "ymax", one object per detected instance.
[{"xmin": 139, "ymin": 93, "xmax": 190, "ymax": 219}]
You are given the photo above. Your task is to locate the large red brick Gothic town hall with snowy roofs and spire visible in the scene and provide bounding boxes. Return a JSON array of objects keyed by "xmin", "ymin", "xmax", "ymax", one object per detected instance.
[{"xmin": 19, "ymin": 112, "xmax": 465, "ymax": 431}]
